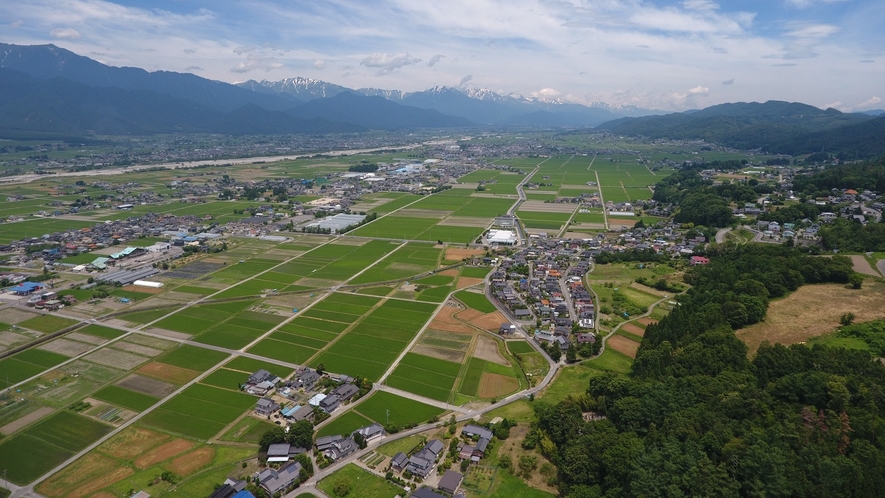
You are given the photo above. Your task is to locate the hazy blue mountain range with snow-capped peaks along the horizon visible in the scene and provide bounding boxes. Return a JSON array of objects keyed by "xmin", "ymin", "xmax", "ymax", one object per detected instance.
[{"xmin": 0, "ymin": 43, "xmax": 885, "ymax": 156}]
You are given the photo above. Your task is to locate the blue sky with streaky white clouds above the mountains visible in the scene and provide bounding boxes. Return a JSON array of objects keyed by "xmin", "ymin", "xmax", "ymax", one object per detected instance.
[{"xmin": 0, "ymin": 0, "xmax": 885, "ymax": 111}]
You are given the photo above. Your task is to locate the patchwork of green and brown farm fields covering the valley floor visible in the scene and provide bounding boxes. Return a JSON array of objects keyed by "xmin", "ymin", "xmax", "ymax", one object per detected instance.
[{"xmin": 0, "ymin": 136, "xmax": 704, "ymax": 498}]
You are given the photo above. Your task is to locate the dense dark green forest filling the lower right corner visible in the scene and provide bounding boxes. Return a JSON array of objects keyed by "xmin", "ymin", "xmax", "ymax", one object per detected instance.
[{"xmin": 525, "ymin": 246, "xmax": 885, "ymax": 498}]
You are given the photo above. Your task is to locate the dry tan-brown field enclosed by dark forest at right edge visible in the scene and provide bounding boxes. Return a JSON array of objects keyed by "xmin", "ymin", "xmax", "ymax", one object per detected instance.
[{"xmin": 736, "ymin": 281, "xmax": 885, "ymax": 353}]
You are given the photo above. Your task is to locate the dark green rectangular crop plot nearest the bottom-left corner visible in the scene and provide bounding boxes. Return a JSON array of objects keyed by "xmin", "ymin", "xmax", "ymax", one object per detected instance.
[{"xmin": 0, "ymin": 411, "xmax": 111, "ymax": 484}]
